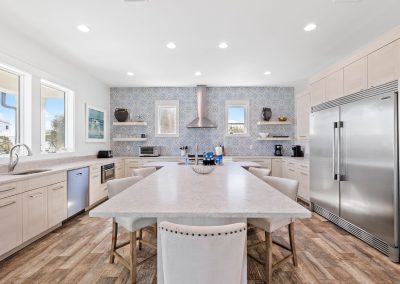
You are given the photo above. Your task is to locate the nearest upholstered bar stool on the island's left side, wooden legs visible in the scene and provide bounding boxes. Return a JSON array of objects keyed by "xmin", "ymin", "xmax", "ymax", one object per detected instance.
[{"xmin": 107, "ymin": 176, "xmax": 157, "ymax": 283}]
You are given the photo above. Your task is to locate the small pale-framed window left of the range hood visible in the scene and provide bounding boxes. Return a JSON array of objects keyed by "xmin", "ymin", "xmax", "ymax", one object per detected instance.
[{"xmin": 155, "ymin": 100, "xmax": 179, "ymax": 137}]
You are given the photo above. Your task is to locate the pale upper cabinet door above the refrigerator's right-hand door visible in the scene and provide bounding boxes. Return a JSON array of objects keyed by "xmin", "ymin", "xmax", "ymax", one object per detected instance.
[{"xmin": 368, "ymin": 43, "xmax": 396, "ymax": 87}]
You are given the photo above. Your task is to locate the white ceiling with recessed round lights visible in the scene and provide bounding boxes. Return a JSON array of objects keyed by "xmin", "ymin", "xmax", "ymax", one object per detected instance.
[{"xmin": 0, "ymin": 0, "xmax": 400, "ymax": 86}]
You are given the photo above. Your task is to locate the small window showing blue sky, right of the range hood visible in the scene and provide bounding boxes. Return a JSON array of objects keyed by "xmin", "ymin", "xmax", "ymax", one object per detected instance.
[{"xmin": 226, "ymin": 101, "xmax": 249, "ymax": 136}]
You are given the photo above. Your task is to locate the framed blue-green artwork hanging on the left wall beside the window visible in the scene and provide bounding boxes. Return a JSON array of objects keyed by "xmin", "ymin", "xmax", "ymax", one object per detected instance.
[{"xmin": 86, "ymin": 105, "xmax": 106, "ymax": 142}]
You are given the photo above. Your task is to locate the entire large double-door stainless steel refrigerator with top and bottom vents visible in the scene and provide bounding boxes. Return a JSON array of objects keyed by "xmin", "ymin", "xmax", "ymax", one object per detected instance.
[{"xmin": 310, "ymin": 81, "xmax": 399, "ymax": 262}]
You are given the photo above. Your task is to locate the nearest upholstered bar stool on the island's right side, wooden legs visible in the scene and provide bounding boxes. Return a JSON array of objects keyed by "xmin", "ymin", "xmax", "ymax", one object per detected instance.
[{"xmin": 247, "ymin": 176, "xmax": 299, "ymax": 283}]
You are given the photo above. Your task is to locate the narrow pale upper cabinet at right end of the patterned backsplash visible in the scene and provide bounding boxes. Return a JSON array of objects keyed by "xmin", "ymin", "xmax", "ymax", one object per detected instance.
[{"xmin": 296, "ymin": 93, "xmax": 311, "ymax": 140}]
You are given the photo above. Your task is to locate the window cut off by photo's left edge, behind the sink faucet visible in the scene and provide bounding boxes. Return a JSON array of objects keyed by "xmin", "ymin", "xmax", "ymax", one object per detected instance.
[{"xmin": 0, "ymin": 69, "xmax": 20, "ymax": 155}]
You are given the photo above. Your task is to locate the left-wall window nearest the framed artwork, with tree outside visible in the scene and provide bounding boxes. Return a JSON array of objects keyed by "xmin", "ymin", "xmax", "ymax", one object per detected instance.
[{"xmin": 40, "ymin": 81, "xmax": 73, "ymax": 153}]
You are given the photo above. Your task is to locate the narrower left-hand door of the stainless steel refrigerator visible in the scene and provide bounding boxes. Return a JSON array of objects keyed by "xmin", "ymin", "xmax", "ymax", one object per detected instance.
[{"xmin": 310, "ymin": 107, "xmax": 339, "ymax": 215}]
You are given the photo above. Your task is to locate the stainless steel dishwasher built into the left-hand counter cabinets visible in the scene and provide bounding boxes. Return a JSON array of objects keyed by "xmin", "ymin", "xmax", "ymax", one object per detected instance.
[{"xmin": 68, "ymin": 167, "xmax": 89, "ymax": 217}]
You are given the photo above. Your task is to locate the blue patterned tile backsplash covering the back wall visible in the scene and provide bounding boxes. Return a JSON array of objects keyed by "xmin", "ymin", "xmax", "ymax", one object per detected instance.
[{"xmin": 110, "ymin": 87, "xmax": 295, "ymax": 156}]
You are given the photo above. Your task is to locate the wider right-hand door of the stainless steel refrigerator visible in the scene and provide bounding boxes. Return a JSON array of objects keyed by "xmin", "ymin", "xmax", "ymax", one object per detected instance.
[{"xmin": 340, "ymin": 93, "xmax": 398, "ymax": 247}]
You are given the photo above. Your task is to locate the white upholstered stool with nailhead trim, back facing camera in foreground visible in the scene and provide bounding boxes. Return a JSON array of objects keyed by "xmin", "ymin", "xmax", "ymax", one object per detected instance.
[{"xmin": 158, "ymin": 222, "xmax": 246, "ymax": 284}]
